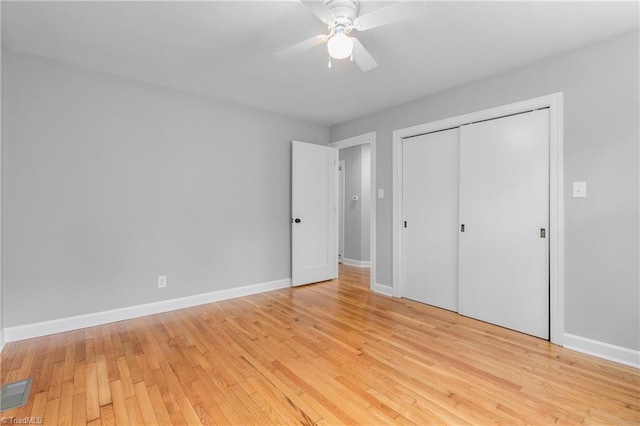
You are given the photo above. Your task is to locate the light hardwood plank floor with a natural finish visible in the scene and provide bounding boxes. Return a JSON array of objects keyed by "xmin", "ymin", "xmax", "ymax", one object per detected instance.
[{"xmin": 0, "ymin": 267, "xmax": 640, "ymax": 425}]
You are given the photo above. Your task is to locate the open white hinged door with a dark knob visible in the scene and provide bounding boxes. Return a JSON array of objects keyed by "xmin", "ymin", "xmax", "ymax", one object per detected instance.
[{"xmin": 291, "ymin": 141, "xmax": 338, "ymax": 286}]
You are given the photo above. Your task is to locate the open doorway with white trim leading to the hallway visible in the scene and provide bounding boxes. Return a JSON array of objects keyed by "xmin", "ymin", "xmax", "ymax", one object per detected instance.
[{"xmin": 330, "ymin": 133, "xmax": 376, "ymax": 290}]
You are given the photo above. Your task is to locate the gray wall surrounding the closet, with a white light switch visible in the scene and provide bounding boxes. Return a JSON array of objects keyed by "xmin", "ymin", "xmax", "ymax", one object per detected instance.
[{"xmin": 331, "ymin": 31, "xmax": 640, "ymax": 350}]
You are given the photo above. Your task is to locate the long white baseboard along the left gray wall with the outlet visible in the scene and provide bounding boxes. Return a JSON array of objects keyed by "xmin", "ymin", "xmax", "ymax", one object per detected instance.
[{"xmin": 2, "ymin": 278, "xmax": 291, "ymax": 342}]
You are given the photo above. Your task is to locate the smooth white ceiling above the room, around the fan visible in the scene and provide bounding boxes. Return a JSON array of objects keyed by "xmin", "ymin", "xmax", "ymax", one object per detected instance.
[{"xmin": 2, "ymin": 0, "xmax": 639, "ymax": 125}]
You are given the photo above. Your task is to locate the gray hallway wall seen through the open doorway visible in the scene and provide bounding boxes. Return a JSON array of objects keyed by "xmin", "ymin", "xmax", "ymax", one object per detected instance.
[{"xmin": 339, "ymin": 144, "xmax": 371, "ymax": 261}]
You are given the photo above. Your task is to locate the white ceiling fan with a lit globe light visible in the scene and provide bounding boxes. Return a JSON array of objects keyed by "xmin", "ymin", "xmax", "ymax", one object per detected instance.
[{"xmin": 276, "ymin": 0, "xmax": 424, "ymax": 71}]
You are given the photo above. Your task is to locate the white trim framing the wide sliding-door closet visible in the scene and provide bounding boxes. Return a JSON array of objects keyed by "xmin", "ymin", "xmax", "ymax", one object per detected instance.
[{"xmin": 392, "ymin": 92, "xmax": 564, "ymax": 345}]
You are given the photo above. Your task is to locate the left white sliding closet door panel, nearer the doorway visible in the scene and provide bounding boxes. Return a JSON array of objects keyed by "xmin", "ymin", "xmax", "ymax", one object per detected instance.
[{"xmin": 402, "ymin": 129, "xmax": 458, "ymax": 311}]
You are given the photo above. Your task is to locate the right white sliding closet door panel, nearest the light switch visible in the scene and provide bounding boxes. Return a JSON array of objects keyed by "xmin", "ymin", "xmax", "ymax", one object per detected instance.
[{"xmin": 458, "ymin": 110, "xmax": 549, "ymax": 339}]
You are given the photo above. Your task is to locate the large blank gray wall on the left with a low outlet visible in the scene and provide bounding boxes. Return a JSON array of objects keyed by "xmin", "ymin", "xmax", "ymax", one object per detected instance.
[{"xmin": 2, "ymin": 51, "xmax": 329, "ymax": 327}]
